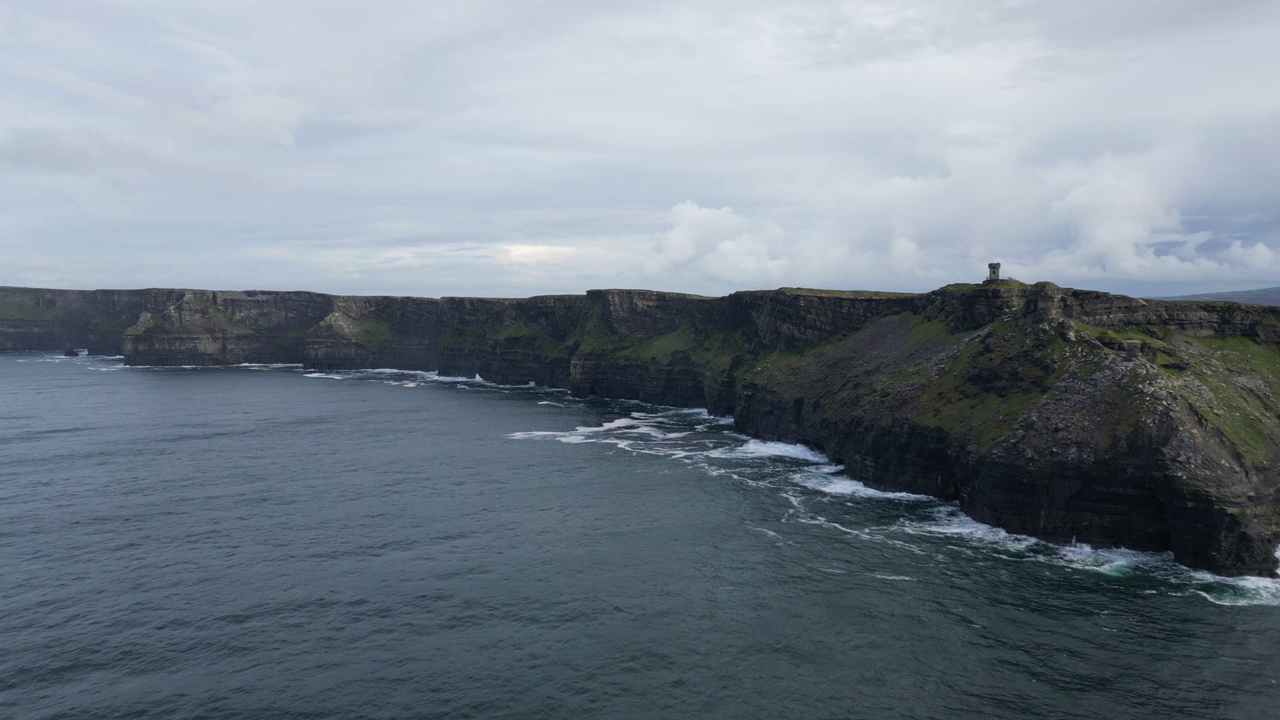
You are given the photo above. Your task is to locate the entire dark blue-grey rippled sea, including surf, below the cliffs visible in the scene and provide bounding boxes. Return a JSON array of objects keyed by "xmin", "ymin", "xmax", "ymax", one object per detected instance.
[{"xmin": 0, "ymin": 354, "xmax": 1280, "ymax": 719}]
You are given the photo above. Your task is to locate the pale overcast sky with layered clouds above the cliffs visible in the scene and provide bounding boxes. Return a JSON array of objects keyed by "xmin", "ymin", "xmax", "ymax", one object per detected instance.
[{"xmin": 0, "ymin": 0, "xmax": 1280, "ymax": 296}]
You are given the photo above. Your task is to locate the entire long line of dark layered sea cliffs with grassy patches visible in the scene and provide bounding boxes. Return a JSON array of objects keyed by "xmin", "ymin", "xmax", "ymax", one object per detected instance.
[{"xmin": 0, "ymin": 282, "xmax": 1280, "ymax": 575}]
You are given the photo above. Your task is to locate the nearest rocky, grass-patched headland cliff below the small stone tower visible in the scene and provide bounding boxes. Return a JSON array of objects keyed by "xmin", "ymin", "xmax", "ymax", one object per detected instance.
[{"xmin": 735, "ymin": 288, "xmax": 1280, "ymax": 574}]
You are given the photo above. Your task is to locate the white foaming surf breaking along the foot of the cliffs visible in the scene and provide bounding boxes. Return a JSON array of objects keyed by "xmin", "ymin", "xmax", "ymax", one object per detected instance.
[{"xmin": 94, "ymin": 356, "xmax": 1280, "ymax": 606}]
